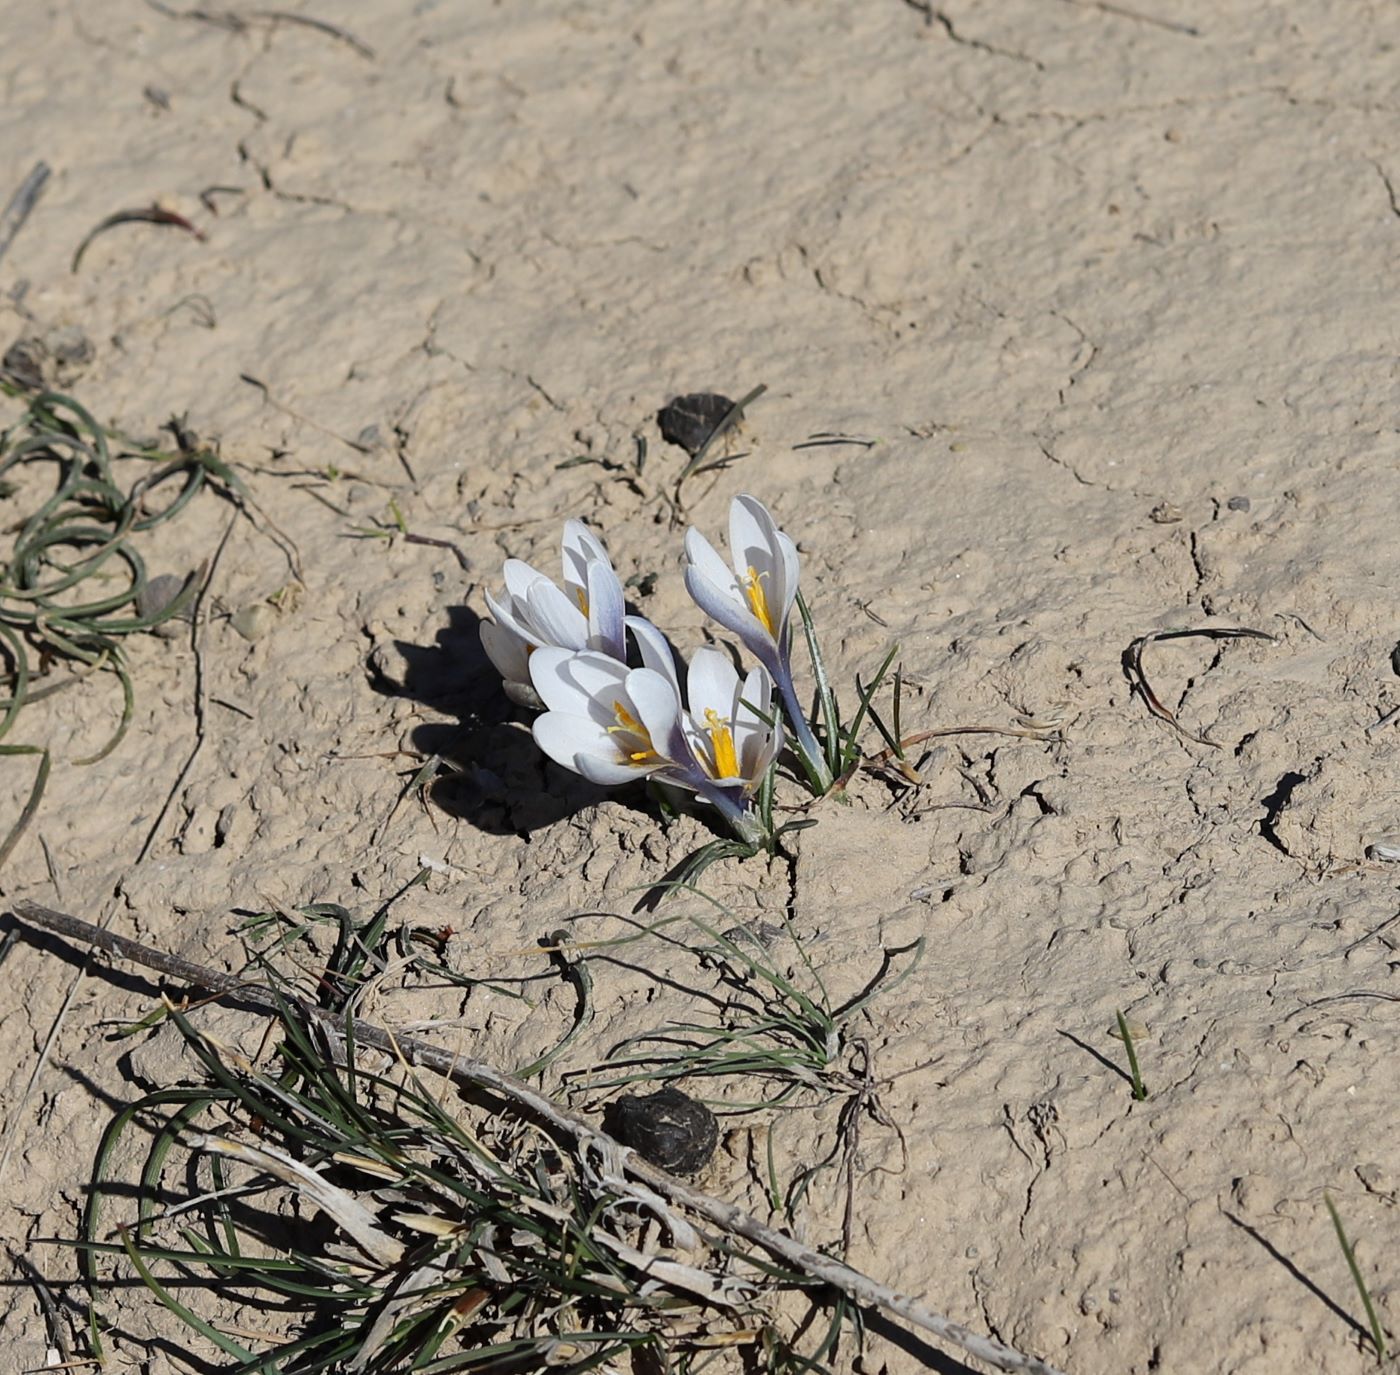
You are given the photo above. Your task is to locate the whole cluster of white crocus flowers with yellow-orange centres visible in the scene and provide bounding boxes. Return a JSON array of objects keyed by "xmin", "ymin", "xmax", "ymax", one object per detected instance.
[{"xmin": 482, "ymin": 496, "xmax": 820, "ymax": 843}]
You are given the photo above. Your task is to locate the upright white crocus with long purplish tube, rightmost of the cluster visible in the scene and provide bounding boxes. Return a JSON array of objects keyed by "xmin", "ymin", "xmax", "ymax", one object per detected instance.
[{"xmin": 686, "ymin": 496, "xmax": 832, "ymax": 791}]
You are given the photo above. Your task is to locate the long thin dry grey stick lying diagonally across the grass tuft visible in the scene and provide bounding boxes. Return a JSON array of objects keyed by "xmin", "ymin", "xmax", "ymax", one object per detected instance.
[{"xmin": 14, "ymin": 902, "xmax": 1063, "ymax": 1375}]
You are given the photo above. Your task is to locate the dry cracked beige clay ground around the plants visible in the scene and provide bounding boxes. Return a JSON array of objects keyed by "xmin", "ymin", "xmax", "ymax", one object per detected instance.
[{"xmin": 0, "ymin": 0, "xmax": 1400, "ymax": 1375}]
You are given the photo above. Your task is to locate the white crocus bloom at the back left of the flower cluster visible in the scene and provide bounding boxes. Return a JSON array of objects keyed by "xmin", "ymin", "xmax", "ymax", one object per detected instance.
[{"xmin": 482, "ymin": 521, "xmax": 627, "ymax": 707}]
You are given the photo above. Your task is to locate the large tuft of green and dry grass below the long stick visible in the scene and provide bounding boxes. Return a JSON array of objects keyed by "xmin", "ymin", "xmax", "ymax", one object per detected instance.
[{"xmin": 65, "ymin": 940, "xmax": 851, "ymax": 1375}]
